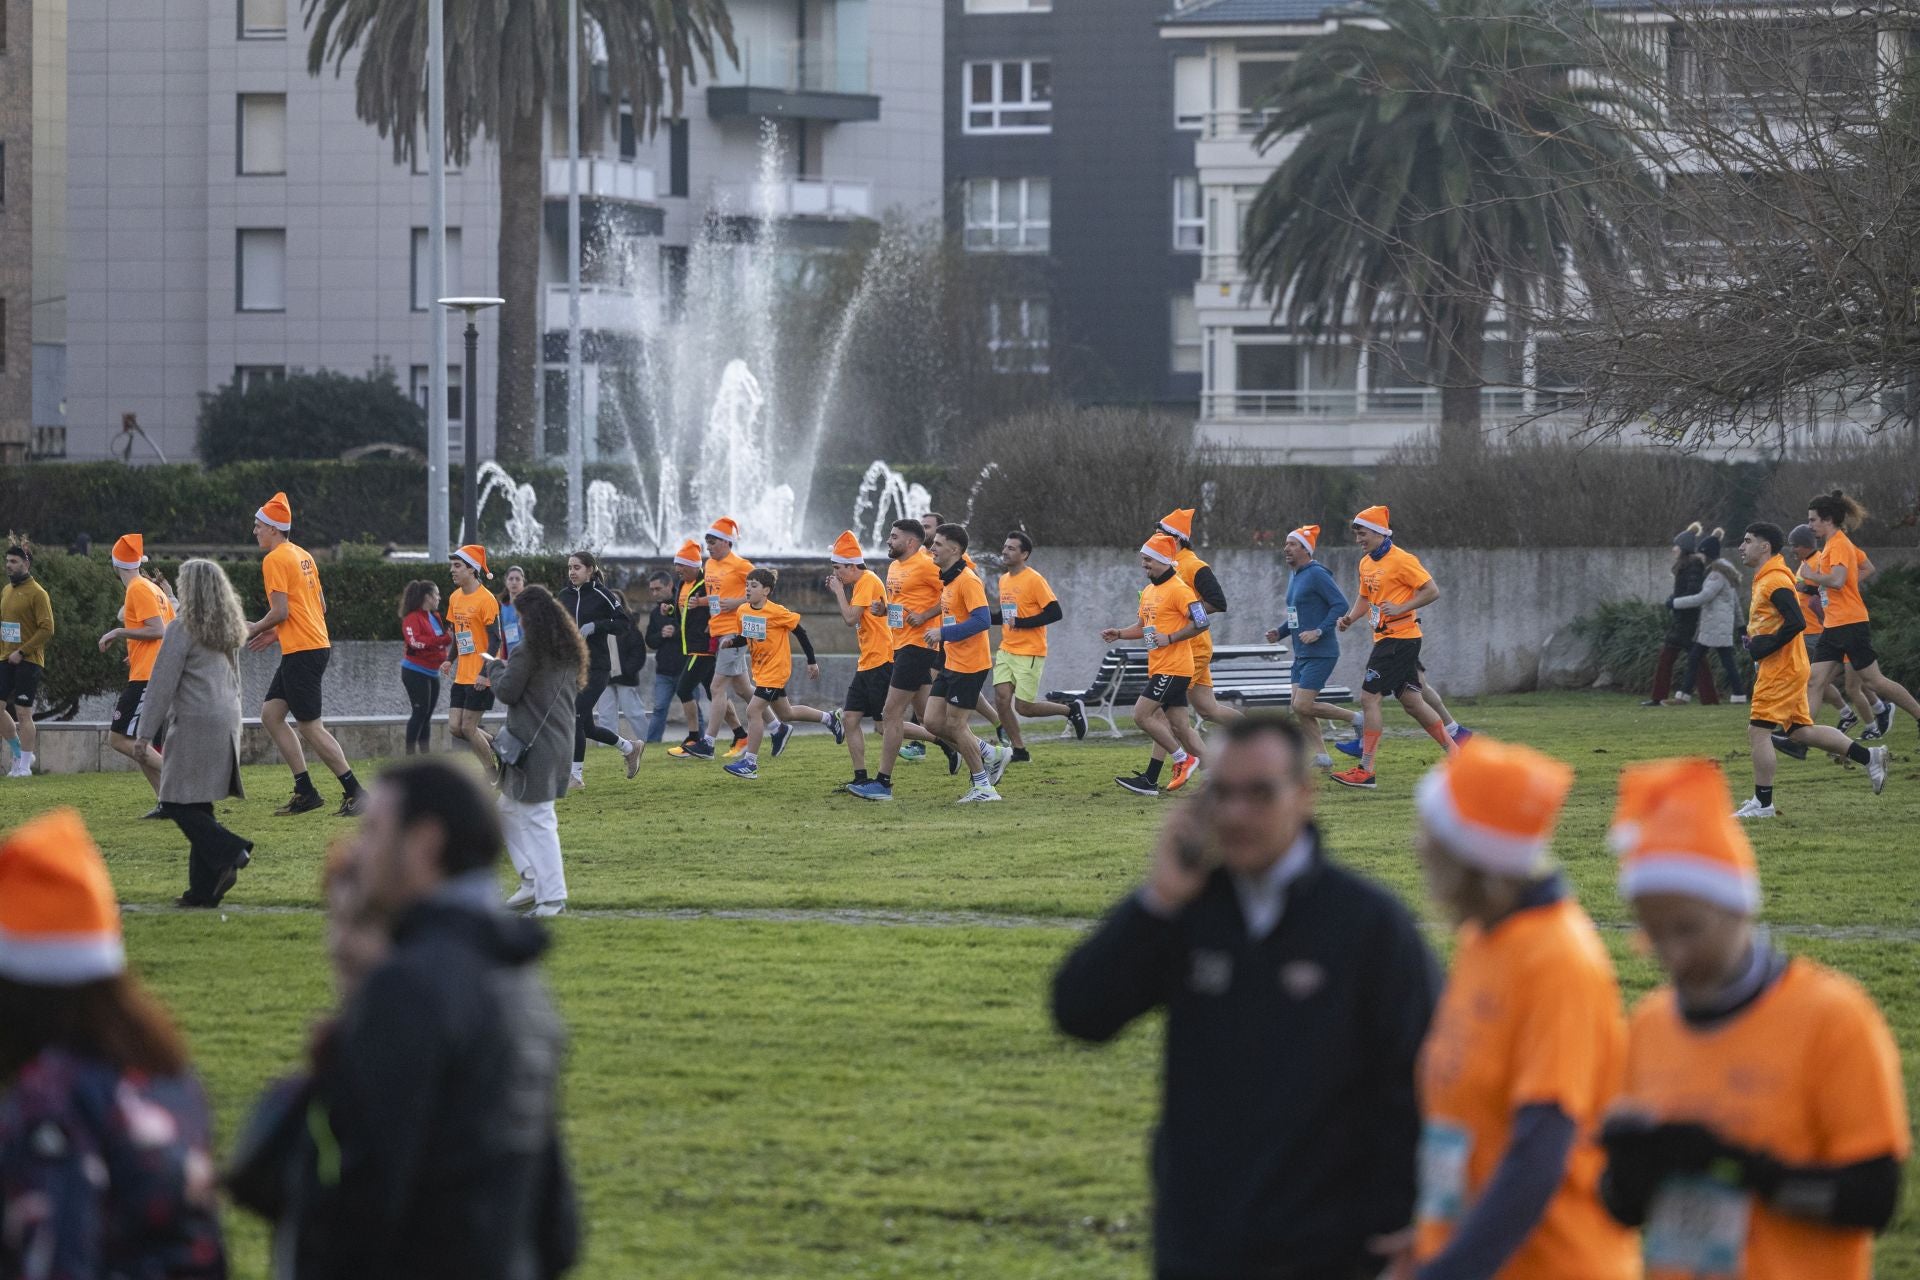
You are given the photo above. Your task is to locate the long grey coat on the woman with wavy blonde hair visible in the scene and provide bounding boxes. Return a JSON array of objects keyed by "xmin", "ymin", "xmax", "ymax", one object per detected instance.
[{"xmin": 140, "ymin": 618, "xmax": 246, "ymax": 804}]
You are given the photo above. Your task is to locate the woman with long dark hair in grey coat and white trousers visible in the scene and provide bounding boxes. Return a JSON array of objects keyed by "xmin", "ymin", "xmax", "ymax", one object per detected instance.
[{"xmin": 486, "ymin": 587, "xmax": 588, "ymax": 915}]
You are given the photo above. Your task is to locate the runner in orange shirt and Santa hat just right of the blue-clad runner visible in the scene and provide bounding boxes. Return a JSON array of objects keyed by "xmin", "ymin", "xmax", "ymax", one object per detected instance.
[{"xmin": 1332, "ymin": 507, "xmax": 1455, "ymax": 791}]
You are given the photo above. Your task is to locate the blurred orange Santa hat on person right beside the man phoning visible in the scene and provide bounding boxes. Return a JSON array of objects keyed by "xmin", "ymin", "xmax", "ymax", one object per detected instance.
[{"xmin": 1413, "ymin": 733, "xmax": 1572, "ymax": 877}]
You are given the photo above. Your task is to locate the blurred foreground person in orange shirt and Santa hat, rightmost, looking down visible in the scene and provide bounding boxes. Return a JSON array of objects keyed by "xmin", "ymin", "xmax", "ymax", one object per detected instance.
[{"xmin": 1599, "ymin": 759, "xmax": 1912, "ymax": 1280}]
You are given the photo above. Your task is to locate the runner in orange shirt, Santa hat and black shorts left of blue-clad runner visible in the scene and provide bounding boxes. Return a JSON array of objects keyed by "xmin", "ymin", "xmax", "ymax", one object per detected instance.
[{"xmin": 1100, "ymin": 533, "xmax": 1208, "ymax": 796}]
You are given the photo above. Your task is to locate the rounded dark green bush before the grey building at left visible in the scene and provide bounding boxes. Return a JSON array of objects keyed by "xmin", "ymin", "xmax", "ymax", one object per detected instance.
[{"xmin": 198, "ymin": 368, "xmax": 426, "ymax": 466}]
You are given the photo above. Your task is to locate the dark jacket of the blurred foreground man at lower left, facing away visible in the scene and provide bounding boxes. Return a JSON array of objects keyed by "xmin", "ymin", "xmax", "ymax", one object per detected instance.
[{"xmin": 317, "ymin": 902, "xmax": 578, "ymax": 1280}]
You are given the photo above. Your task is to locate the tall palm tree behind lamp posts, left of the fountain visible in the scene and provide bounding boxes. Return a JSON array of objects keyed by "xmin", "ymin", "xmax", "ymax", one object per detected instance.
[{"xmin": 303, "ymin": 0, "xmax": 733, "ymax": 461}]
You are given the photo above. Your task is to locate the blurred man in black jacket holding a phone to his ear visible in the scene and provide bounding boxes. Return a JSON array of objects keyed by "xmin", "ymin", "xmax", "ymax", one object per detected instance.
[{"xmin": 1054, "ymin": 716, "xmax": 1440, "ymax": 1280}]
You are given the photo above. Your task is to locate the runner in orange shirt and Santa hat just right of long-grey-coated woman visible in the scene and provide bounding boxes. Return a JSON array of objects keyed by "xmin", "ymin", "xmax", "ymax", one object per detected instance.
[{"xmin": 246, "ymin": 493, "xmax": 367, "ymax": 818}]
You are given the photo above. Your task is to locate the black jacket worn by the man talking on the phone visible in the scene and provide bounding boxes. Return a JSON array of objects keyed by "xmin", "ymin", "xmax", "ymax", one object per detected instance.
[{"xmin": 1054, "ymin": 833, "xmax": 1440, "ymax": 1280}]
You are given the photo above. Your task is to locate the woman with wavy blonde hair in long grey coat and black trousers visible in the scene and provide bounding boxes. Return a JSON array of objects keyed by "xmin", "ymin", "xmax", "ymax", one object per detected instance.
[{"xmin": 140, "ymin": 560, "xmax": 253, "ymax": 906}]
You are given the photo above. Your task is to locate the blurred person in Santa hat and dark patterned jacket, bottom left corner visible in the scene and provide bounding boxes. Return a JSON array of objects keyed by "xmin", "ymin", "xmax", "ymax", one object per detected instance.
[{"xmin": 0, "ymin": 810, "xmax": 227, "ymax": 1280}]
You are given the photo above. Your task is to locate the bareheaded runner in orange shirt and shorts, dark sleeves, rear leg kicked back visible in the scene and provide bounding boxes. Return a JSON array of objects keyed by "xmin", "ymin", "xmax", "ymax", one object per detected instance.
[{"xmin": 1734, "ymin": 522, "xmax": 1887, "ymax": 819}]
